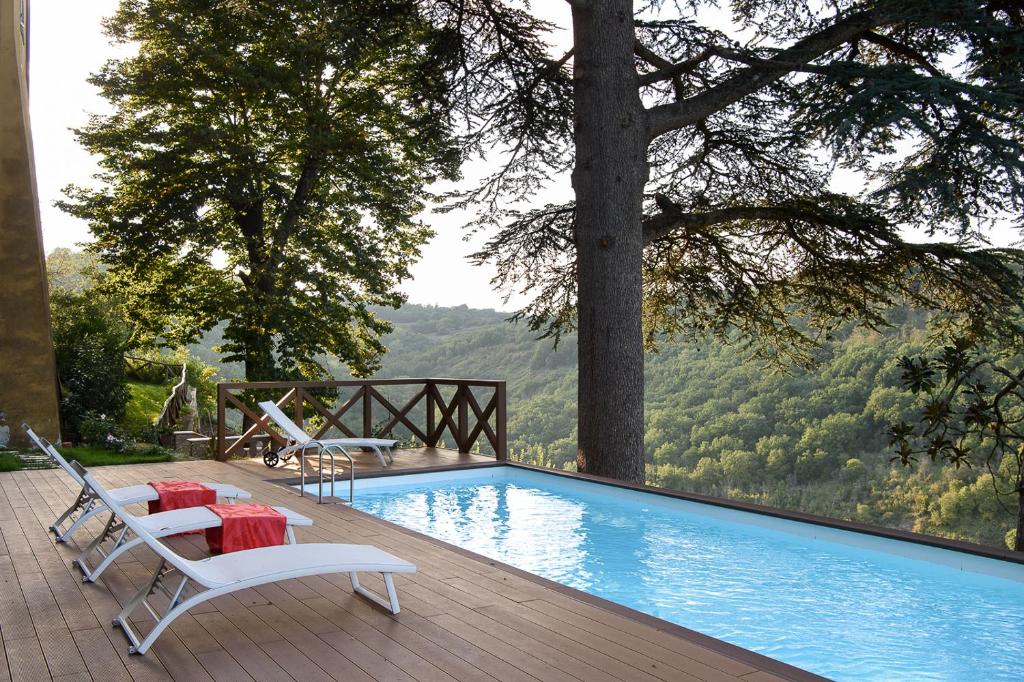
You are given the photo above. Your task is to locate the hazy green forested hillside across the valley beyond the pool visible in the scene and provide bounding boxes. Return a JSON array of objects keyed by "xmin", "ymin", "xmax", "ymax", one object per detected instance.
[{"xmin": 192, "ymin": 305, "xmax": 1014, "ymax": 547}]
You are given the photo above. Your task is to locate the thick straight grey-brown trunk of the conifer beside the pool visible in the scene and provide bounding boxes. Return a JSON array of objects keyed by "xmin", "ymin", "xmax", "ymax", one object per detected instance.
[{"xmin": 572, "ymin": 0, "xmax": 647, "ymax": 482}]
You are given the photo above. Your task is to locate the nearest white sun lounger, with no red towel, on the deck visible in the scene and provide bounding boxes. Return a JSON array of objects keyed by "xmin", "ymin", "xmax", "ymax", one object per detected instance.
[{"xmin": 72, "ymin": 462, "xmax": 416, "ymax": 653}]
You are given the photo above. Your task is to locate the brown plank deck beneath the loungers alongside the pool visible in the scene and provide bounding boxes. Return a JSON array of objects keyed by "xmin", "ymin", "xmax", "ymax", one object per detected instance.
[{"xmin": 0, "ymin": 452, "xmax": 801, "ymax": 682}]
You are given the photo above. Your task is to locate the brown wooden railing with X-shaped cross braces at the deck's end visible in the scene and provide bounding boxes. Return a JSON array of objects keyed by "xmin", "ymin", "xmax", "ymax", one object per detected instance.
[{"xmin": 216, "ymin": 379, "xmax": 508, "ymax": 460}]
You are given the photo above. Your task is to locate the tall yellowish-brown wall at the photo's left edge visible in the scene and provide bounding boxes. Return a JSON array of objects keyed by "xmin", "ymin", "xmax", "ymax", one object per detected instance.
[{"xmin": 0, "ymin": 0, "xmax": 59, "ymax": 444}]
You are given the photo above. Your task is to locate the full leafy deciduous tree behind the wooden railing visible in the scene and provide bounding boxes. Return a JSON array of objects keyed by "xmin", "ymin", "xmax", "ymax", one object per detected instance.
[{"xmin": 61, "ymin": 0, "xmax": 459, "ymax": 380}]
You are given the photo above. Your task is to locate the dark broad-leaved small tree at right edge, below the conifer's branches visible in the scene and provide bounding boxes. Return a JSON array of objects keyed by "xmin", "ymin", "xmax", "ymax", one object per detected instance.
[{"xmin": 890, "ymin": 341, "xmax": 1024, "ymax": 552}]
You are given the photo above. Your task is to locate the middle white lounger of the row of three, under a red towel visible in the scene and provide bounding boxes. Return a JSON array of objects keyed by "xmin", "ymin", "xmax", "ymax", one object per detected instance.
[{"xmin": 75, "ymin": 497, "xmax": 313, "ymax": 583}]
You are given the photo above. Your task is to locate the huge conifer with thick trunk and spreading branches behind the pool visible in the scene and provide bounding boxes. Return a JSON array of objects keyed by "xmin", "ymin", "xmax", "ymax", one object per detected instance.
[{"xmin": 420, "ymin": 0, "xmax": 1024, "ymax": 480}]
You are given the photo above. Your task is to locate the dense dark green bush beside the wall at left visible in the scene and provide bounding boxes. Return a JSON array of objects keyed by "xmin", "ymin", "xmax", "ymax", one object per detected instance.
[{"xmin": 50, "ymin": 289, "xmax": 130, "ymax": 436}]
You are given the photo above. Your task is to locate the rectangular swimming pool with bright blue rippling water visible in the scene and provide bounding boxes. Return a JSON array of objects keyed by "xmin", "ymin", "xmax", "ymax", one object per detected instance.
[{"xmin": 294, "ymin": 466, "xmax": 1024, "ymax": 680}]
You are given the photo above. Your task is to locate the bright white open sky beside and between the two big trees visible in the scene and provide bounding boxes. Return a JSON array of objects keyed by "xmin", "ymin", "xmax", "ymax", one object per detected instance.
[{"xmin": 30, "ymin": 0, "xmax": 568, "ymax": 310}]
